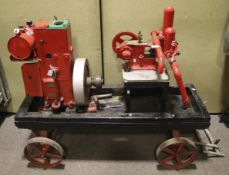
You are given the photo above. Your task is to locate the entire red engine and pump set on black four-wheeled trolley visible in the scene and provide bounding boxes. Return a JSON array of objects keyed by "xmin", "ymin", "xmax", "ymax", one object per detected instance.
[{"xmin": 8, "ymin": 7, "xmax": 216, "ymax": 170}]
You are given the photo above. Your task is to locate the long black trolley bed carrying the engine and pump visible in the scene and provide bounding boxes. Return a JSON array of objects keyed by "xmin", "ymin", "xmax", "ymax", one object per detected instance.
[{"xmin": 15, "ymin": 85, "xmax": 210, "ymax": 133}]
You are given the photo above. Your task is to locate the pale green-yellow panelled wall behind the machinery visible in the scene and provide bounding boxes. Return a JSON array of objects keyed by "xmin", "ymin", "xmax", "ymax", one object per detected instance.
[{"xmin": 0, "ymin": 0, "xmax": 229, "ymax": 112}]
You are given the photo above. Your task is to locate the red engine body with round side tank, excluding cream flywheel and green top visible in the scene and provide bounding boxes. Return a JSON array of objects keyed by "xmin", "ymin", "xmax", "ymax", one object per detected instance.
[{"xmin": 8, "ymin": 20, "xmax": 74, "ymax": 109}]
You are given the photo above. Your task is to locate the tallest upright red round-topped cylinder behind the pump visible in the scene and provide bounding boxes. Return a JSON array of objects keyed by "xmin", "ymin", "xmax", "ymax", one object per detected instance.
[{"xmin": 162, "ymin": 6, "xmax": 174, "ymax": 34}]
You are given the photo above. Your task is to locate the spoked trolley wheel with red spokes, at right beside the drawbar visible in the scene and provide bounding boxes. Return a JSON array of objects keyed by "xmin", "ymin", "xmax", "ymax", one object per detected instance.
[{"xmin": 156, "ymin": 137, "xmax": 197, "ymax": 170}]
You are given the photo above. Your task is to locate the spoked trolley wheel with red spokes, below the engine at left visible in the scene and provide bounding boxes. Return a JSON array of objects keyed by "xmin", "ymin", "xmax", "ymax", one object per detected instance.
[{"xmin": 24, "ymin": 137, "xmax": 64, "ymax": 169}]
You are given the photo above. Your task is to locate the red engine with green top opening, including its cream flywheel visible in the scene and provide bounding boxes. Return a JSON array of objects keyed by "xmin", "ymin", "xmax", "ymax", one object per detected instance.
[{"xmin": 8, "ymin": 19, "xmax": 102, "ymax": 110}]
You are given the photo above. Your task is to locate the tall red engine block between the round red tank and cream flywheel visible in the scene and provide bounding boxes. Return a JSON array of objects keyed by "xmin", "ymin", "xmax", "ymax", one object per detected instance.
[{"xmin": 34, "ymin": 21, "xmax": 74, "ymax": 108}]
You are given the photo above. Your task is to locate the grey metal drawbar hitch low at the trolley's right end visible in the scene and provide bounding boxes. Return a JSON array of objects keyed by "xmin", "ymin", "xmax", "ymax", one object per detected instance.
[{"xmin": 195, "ymin": 129, "xmax": 225, "ymax": 157}]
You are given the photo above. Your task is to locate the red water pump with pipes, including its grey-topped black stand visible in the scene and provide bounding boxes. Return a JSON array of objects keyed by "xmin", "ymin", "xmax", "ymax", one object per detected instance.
[{"xmin": 112, "ymin": 7, "xmax": 190, "ymax": 111}]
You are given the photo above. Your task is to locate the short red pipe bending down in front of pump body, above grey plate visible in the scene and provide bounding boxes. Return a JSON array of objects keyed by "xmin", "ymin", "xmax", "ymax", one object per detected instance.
[{"xmin": 151, "ymin": 31, "xmax": 165, "ymax": 74}]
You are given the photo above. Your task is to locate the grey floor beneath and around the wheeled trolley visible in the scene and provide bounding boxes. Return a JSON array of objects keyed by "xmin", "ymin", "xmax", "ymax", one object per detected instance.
[{"xmin": 0, "ymin": 116, "xmax": 229, "ymax": 175}]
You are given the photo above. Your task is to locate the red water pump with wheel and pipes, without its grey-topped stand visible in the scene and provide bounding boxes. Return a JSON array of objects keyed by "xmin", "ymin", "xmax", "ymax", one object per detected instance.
[{"xmin": 112, "ymin": 7, "xmax": 190, "ymax": 107}]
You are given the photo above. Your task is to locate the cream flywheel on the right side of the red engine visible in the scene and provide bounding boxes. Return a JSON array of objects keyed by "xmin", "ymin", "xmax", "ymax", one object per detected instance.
[{"xmin": 72, "ymin": 58, "xmax": 90, "ymax": 106}]
